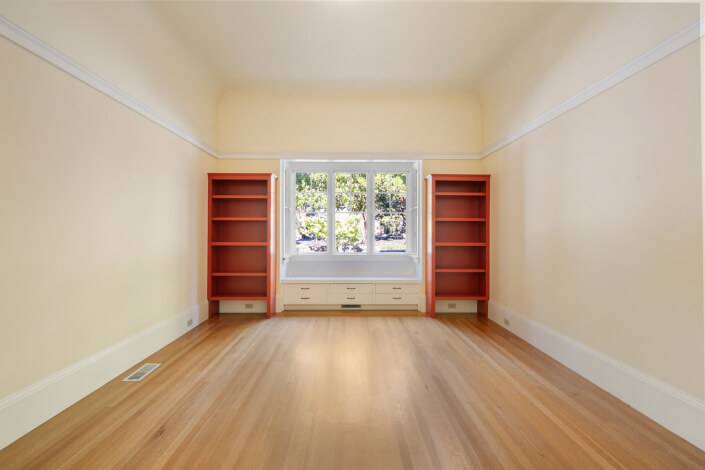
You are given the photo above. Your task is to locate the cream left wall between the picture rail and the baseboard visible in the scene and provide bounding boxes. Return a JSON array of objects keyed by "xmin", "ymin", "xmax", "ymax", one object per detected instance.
[{"xmin": 0, "ymin": 33, "xmax": 215, "ymax": 398}]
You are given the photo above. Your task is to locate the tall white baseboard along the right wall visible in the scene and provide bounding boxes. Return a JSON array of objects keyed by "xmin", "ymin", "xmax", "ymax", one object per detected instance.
[{"xmin": 489, "ymin": 302, "xmax": 705, "ymax": 450}]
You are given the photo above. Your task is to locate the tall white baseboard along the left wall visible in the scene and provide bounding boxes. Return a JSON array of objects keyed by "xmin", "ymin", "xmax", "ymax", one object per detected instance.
[{"xmin": 0, "ymin": 302, "xmax": 208, "ymax": 449}]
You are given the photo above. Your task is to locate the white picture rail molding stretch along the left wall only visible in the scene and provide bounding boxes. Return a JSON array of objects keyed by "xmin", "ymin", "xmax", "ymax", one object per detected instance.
[{"xmin": 0, "ymin": 16, "xmax": 218, "ymax": 157}]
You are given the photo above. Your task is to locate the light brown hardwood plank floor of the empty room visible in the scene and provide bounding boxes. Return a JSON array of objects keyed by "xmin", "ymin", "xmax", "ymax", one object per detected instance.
[{"xmin": 0, "ymin": 312, "xmax": 705, "ymax": 470}]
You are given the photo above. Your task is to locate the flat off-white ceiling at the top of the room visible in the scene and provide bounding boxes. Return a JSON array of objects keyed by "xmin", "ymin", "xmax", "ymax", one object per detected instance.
[{"xmin": 152, "ymin": 1, "xmax": 557, "ymax": 89}]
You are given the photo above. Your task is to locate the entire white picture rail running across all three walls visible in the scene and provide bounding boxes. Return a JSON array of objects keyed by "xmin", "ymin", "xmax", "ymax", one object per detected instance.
[{"xmin": 0, "ymin": 16, "xmax": 705, "ymax": 160}]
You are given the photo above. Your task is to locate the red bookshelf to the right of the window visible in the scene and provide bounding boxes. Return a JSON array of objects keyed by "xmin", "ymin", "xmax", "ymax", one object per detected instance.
[{"xmin": 426, "ymin": 175, "xmax": 490, "ymax": 317}]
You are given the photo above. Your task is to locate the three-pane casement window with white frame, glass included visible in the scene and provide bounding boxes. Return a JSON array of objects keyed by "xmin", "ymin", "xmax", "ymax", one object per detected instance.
[{"xmin": 282, "ymin": 161, "xmax": 419, "ymax": 260}]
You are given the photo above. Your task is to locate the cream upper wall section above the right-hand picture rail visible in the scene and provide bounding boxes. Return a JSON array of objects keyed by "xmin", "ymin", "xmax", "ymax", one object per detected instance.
[{"xmin": 478, "ymin": 3, "xmax": 699, "ymax": 148}]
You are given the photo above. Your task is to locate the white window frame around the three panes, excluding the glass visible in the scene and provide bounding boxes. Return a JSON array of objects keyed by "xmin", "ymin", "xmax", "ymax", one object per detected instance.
[{"xmin": 280, "ymin": 160, "xmax": 421, "ymax": 260}]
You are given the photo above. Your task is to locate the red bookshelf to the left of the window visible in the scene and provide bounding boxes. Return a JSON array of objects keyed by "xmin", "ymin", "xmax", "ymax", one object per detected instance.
[{"xmin": 208, "ymin": 173, "xmax": 276, "ymax": 318}]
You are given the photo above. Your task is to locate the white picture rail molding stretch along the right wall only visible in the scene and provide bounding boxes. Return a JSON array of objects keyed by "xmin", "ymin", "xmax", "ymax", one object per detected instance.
[{"xmin": 481, "ymin": 18, "xmax": 705, "ymax": 158}]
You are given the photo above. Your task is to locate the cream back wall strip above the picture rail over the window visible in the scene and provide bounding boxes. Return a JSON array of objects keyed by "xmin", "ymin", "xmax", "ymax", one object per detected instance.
[{"xmin": 217, "ymin": 90, "xmax": 482, "ymax": 153}]
